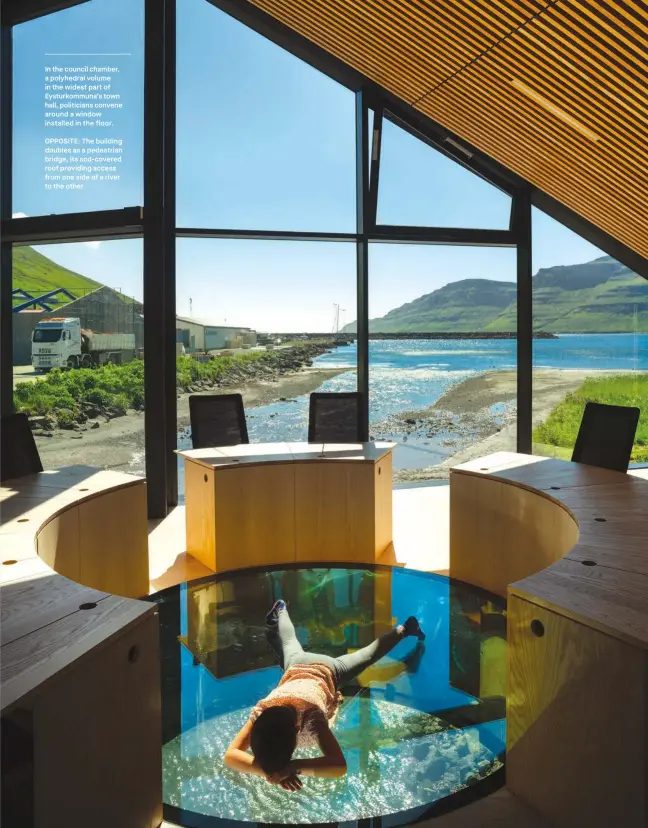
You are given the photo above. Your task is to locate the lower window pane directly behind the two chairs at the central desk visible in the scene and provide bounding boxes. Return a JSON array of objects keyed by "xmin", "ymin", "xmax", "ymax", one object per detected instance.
[{"xmin": 176, "ymin": 239, "xmax": 357, "ymax": 498}]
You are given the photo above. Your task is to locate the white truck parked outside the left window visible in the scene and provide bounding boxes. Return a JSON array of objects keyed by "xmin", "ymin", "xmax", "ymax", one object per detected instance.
[{"xmin": 32, "ymin": 316, "xmax": 137, "ymax": 372}]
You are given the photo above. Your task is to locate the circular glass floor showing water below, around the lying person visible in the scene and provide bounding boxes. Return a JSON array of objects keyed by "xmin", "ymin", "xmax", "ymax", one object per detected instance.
[{"xmin": 151, "ymin": 565, "xmax": 506, "ymax": 828}]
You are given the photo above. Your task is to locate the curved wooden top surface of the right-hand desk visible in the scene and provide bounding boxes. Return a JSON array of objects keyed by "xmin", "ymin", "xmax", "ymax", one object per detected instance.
[{"xmin": 451, "ymin": 452, "xmax": 648, "ymax": 649}]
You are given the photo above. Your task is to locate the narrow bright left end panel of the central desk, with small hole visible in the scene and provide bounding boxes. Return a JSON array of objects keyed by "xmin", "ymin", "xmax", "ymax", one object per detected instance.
[{"xmin": 184, "ymin": 458, "xmax": 216, "ymax": 571}]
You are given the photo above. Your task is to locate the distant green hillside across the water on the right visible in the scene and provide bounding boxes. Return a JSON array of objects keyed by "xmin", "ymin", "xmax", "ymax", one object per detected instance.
[{"xmin": 344, "ymin": 256, "xmax": 648, "ymax": 333}]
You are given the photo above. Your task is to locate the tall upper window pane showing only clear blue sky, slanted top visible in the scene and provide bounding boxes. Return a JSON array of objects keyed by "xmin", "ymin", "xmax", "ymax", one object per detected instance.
[{"xmin": 177, "ymin": 0, "xmax": 355, "ymax": 232}]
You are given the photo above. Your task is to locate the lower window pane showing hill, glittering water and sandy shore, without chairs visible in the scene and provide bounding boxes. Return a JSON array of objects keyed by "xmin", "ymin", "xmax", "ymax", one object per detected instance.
[{"xmin": 369, "ymin": 244, "xmax": 517, "ymax": 482}]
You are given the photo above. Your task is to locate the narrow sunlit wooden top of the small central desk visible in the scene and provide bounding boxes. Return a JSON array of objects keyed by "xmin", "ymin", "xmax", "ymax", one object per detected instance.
[{"xmin": 176, "ymin": 442, "xmax": 395, "ymax": 469}]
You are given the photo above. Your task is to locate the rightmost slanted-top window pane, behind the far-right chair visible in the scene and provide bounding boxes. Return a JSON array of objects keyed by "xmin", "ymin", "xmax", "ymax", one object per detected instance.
[{"xmin": 533, "ymin": 210, "xmax": 648, "ymax": 463}]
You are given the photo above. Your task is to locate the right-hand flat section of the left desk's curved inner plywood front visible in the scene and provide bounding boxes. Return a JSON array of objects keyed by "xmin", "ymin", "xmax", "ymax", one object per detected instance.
[{"xmin": 78, "ymin": 483, "xmax": 149, "ymax": 598}]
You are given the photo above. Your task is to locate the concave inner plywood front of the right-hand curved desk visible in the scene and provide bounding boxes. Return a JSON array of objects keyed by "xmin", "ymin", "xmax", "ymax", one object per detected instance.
[{"xmin": 450, "ymin": 471, "xmax": 578, "ymax": 595}]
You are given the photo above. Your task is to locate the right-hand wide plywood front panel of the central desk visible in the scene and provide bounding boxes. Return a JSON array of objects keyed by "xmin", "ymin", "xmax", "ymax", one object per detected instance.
[{"xmin": 294, "ymin": 460, "xmax": 374, "ymax": 563}]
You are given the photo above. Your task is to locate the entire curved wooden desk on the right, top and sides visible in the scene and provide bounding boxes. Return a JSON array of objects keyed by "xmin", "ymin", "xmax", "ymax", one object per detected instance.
[{"xmin": 450, "ymin": 453, "xmax": 648, "ymax": 828}]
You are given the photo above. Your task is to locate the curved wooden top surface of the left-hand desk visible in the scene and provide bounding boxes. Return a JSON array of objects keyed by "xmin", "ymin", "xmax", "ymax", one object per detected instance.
[{"xmin": 0, "ymin": 466, "xmax": 155, "ymax": 711}]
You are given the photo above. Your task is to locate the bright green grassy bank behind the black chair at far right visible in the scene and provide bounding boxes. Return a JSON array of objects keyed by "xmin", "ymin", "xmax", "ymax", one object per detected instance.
[{"xmin": 533, "ymin": 374, "xmax": 648, "ymax": 463}]
